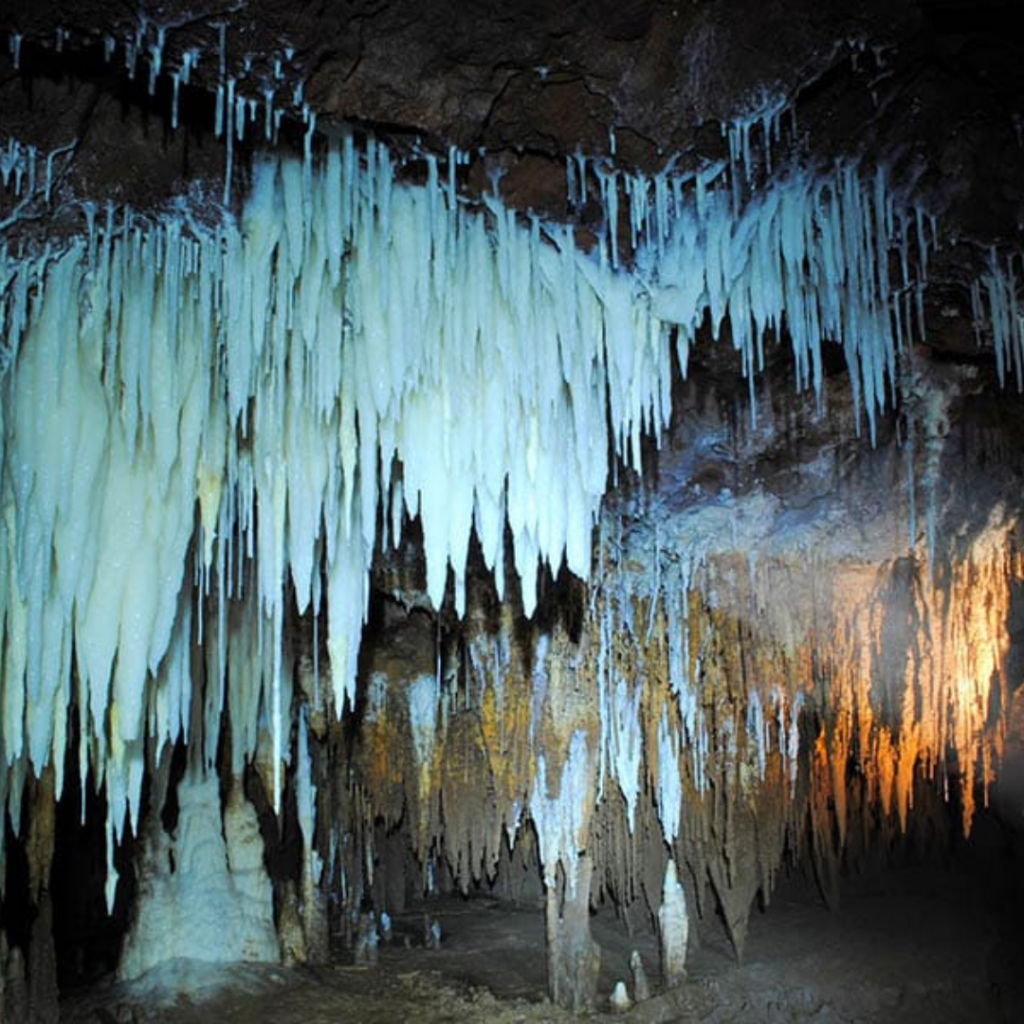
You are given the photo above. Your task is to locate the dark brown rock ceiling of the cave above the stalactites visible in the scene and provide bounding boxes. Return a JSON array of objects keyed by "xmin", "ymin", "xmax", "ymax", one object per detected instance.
[{"xmin": 0, "ymin": 0, "xmax": 1024, "ymax": 264}]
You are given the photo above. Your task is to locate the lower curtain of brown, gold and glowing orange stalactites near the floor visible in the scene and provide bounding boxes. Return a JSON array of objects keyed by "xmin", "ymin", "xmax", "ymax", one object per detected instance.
[{"xmin": 332, "ymin": 520, "xmax": 1024, "ymax": 948}]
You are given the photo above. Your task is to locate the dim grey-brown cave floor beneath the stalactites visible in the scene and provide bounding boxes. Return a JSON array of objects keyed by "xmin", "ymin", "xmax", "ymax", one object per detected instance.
[{"xmin": 62, "ymin": 839, "xmax": 1024, "ymax": 1024}]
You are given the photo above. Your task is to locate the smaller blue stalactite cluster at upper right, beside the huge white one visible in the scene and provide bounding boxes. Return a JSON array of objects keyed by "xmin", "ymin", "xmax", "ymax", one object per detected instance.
[{"xmin": 632, "ymin": 164, "xmax": 898, "ymax": 441}]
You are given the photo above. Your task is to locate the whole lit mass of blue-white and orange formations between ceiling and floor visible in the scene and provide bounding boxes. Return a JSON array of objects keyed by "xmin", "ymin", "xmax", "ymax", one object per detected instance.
[{"xmin": 0, "ymin": 2, "xmax": 1024, "ymax": 1008}]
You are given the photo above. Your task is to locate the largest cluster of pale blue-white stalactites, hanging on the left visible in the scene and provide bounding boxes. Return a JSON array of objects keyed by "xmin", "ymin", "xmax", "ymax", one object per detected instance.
[{"xmin": 0, "ymin": 138, "xmax": 671, "ymax": 888}]
